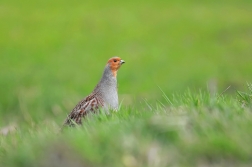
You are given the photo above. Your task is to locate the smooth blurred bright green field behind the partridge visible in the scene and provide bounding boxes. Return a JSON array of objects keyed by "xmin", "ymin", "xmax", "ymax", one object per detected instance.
[{"xmin": 0, "ymin": 0, "xmax": 252, "ymax": 126}]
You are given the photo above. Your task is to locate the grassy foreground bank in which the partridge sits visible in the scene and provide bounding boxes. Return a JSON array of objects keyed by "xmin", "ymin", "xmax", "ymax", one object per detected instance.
[{"xmin": 0, "ymin": 91, "xmax": 252, "ymax": 167}]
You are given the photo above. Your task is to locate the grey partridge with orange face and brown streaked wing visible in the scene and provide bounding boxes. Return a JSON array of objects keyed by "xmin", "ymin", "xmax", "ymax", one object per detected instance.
[{"xmin": 64, "ymin": 57, "xmax": 125, "ymax": 126}]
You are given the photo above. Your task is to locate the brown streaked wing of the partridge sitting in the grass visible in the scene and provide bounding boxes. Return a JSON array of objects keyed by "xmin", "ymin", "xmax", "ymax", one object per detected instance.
[{"xmin": 64, "ymin": 94, "xmax": 103, "ymax": 126}]
